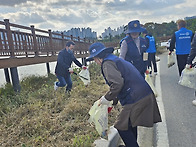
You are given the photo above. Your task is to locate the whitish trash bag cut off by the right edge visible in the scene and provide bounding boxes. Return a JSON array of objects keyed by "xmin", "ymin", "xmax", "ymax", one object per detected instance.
[{"xmin": 178, "ymin": 67, "xmax": 196, "ymax": 89}]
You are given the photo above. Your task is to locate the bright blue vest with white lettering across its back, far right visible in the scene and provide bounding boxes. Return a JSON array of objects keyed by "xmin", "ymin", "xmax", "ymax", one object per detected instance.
[{"xmin": 175, "ymin": 28, "xmax": 193, "ymax": 55}]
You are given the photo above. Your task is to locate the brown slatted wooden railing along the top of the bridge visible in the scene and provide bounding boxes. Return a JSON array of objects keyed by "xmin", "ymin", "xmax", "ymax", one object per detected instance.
[{"xmin": 0, "ymin": 19, "xmax": 93, "ymax": 57}]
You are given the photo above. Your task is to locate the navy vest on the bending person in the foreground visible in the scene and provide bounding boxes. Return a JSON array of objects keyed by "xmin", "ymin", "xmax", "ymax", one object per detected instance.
[{"xmin": 101, "ymin": 54, "xmax": 153, "ymax": 105}]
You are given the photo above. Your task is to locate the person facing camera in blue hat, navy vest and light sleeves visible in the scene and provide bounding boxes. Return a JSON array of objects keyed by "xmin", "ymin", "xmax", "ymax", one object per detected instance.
[{"xmin": 119, "ymin": 20, "xmax": 147, "ymax": 77}]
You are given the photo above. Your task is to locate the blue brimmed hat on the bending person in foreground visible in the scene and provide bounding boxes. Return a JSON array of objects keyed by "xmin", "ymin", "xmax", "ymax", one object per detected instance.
[{"xmin": 86, "ymin": 42, "xmax": 114, "ymax": 61}]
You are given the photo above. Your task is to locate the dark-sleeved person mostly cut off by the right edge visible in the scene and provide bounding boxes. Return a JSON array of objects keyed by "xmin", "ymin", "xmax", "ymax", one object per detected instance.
[{"xmin": 186, "ymin": 34, "xmax": 196, "ymax": 106}]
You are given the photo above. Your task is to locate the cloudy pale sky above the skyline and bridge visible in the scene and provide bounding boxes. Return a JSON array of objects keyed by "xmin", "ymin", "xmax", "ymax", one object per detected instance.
[{"xmin": 0, "ymin": 0, "xmax": 196, "ymax": 35}]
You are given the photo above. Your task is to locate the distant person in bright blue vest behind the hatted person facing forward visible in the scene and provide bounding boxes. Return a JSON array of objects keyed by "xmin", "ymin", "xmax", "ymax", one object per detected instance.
[{"xmin": 143, "ymin": 30, "xmax": 157, "ymax": 75}]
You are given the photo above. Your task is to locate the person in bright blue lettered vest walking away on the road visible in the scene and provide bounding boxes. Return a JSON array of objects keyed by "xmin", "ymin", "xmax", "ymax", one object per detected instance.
[{"xmin": 169, "ymin": 20, "xmax": 193, "ymax": 75}]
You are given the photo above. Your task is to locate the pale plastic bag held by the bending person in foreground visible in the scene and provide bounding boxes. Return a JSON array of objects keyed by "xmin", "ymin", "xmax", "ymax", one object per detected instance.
[{"xmin": 89, "ymin": 100, "xmax": 108, "ymax": 137}]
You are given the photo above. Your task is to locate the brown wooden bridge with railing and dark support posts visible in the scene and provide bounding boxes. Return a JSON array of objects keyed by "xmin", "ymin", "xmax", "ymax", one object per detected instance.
[{"xmin": 0, "ymin": 19, "xmax": 117, "ymax": 91}]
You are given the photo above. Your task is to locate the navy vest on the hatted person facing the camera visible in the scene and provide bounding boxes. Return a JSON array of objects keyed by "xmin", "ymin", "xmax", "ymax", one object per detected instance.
[{"xmin": 125, "ymin": 36, "xmax": 147, "ymax": 73}]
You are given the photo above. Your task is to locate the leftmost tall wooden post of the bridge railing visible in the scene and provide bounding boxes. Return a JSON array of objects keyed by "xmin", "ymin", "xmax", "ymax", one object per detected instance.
[{"xmin": 4, "ymin": 19, "xmax": 14, "ymax": 57}]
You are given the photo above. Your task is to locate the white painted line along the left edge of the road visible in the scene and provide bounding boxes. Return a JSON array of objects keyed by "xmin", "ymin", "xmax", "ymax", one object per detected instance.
[{"xmin": 155, "ymin": 61, "xmax": 169, "ymax": 147}]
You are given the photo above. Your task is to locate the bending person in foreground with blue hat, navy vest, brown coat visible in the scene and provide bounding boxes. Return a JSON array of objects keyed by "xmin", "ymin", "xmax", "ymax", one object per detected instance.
[{"xmin": 87, "ymin": 42, "xmax": 161, "ymax": 147}]
